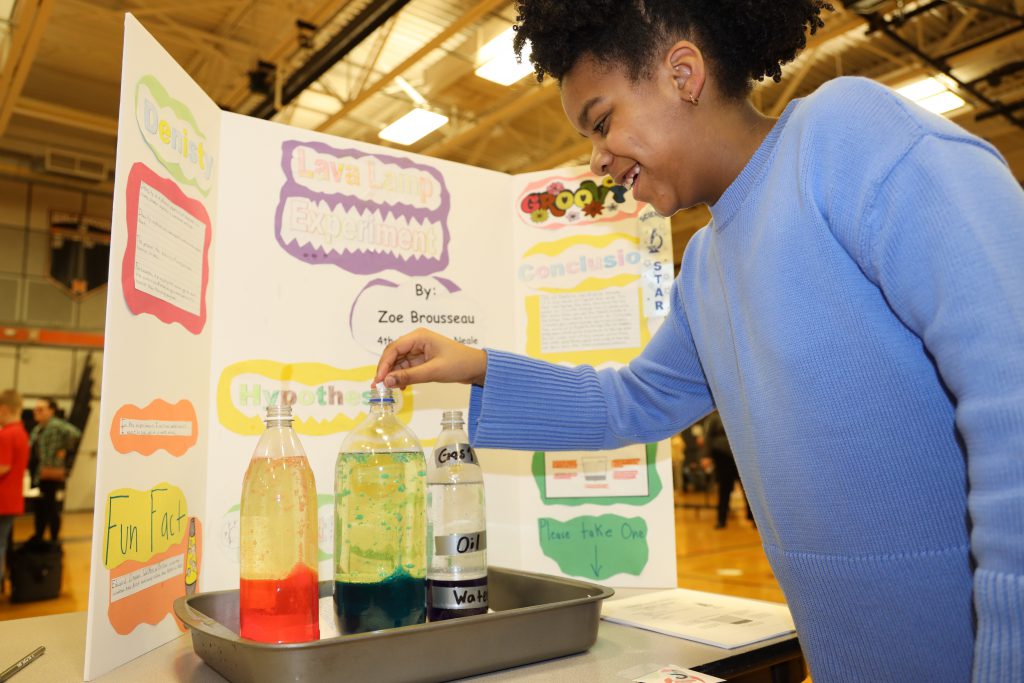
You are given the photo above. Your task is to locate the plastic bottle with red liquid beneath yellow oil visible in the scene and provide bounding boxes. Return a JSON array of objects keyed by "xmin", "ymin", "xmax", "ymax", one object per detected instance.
[{"xmin": 239, "ymin": 405, "xmax": 319, "ymax": 643}]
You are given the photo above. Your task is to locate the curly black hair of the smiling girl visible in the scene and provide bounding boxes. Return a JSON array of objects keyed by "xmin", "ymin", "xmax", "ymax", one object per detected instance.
[{"xmin": 513, "ymin": 0, "xmax": 834, "ymax": 98}]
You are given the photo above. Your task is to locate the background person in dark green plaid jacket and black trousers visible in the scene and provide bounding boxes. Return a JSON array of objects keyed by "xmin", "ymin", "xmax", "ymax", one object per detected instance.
[{"xmin": 31, "ymin": 398, "xmax": 82, "ymax": 542}]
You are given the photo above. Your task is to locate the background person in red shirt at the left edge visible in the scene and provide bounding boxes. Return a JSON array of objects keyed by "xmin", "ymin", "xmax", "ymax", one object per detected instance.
[{"xmin": 0, "ymin": 389, "xmax": 29, "ymax": 589}]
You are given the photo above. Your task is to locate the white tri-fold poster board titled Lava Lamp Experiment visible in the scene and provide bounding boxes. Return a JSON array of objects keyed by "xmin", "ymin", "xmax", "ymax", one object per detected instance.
[{"xmin": 85, "ymin": 15, "xmax": 676, "ymax": 679}]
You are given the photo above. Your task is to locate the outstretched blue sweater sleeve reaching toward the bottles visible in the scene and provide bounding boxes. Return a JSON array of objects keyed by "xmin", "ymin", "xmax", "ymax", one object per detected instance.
[{"xmin": 469, "ymin": 281, "xmax": 712, "ymax": 451}]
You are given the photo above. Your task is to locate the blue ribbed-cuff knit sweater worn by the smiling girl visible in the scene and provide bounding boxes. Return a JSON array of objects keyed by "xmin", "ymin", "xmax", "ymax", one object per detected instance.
[{"xmin": 470, "ymin": 78, "xmax": 1024, "ymax": 683}]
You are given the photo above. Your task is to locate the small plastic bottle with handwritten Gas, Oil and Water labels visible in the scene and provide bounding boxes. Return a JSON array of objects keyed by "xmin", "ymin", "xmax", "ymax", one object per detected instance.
[{"xmin": 427, "ymin": 411, "xmax": 487, "ymax": 622}]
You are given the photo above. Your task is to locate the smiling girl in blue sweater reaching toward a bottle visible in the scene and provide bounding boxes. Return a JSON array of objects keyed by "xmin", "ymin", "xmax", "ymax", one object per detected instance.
[{"xmin": 376, "ymin": 0, "xmax": 1024, "ymax": 683}]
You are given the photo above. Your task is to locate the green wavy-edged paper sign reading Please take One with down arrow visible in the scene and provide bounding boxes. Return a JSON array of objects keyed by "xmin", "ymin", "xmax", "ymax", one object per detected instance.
[{"xmin": 538, "ymin": 514, "xmax": 649, "ymax": 581}]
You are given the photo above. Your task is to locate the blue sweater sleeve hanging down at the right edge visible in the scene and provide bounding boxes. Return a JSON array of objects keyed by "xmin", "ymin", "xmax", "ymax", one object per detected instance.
[{"xmin": 860, "ymin": 133, "xmax": 1024, "ymax": 683}]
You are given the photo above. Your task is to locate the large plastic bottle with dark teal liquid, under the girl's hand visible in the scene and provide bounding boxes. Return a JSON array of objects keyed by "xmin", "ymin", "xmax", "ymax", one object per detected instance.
[{"xmin": 334, "ymin": 386, "xmax": 427, "ymax": 634}]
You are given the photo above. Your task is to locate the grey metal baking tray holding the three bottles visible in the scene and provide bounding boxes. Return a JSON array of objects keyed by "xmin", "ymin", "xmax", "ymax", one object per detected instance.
[{"xmin": 174, "ymin": 567, "xmax": 614, "ymax": 683}]
